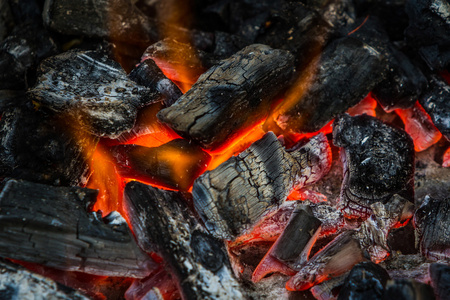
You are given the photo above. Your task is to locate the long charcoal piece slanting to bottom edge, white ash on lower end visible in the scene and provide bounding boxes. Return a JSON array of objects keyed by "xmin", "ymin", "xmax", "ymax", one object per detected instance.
[{"xmin": 124, "ymin": 181, "xmax": 243, "ymax": 299}]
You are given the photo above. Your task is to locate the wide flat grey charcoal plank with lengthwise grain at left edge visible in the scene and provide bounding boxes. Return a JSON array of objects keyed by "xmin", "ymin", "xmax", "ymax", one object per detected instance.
[{"xmin": 0, "ymin": 180, "xmax": 156, "ymax": 278}]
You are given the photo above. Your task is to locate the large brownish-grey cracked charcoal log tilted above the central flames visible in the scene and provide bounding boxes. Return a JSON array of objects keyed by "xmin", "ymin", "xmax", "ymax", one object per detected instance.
[{"xmin": 158, "ymin": 44, "xmax": 294, "ymax": 149}]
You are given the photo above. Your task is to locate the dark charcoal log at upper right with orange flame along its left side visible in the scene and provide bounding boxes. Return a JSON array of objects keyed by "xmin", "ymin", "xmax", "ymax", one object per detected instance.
[{"xmin": 272, "ymin": 37, "xmax": 385, "ymax": 132}]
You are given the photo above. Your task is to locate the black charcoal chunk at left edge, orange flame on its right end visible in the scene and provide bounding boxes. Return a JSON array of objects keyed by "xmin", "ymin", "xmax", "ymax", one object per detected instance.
[{"xmin": 0, "ymin": 106, "xmax": 98, "ymax": 186}]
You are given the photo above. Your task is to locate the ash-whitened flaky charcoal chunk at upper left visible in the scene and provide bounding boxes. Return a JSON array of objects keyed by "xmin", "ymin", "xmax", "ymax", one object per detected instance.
[{"xmin": 29, "ymin": 51, "xmax": 158, "ymax": 137}]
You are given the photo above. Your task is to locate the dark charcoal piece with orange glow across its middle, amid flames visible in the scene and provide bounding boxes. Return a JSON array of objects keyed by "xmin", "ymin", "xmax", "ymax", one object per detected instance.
[{"xmin": 110, "ymin": 139, "xmax": 211, "ymax": 191}]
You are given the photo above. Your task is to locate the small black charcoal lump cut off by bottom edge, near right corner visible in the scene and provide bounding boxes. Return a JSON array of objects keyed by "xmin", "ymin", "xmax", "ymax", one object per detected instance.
[{"xmin": 383, "ymin": 279, "xmax": 435, "ymax": 300}]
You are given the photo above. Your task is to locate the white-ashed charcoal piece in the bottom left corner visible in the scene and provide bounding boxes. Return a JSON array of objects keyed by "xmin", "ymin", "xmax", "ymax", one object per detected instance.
[{"xmin": 0, "ymin": 260, "xmax": 89, "ymax": 300}]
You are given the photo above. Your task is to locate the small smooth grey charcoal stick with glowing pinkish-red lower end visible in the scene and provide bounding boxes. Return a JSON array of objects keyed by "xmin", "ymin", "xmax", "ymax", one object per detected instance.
[{"xmin": 252, "ymin": 204, "xmax": 322, "ymax": 282}]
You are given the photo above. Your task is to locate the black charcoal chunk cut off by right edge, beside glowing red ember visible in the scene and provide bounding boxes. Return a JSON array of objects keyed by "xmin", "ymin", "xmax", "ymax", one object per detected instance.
[{"xmin": 419, "ymin": 76, "xmax": 450, "ymax": 141}]
